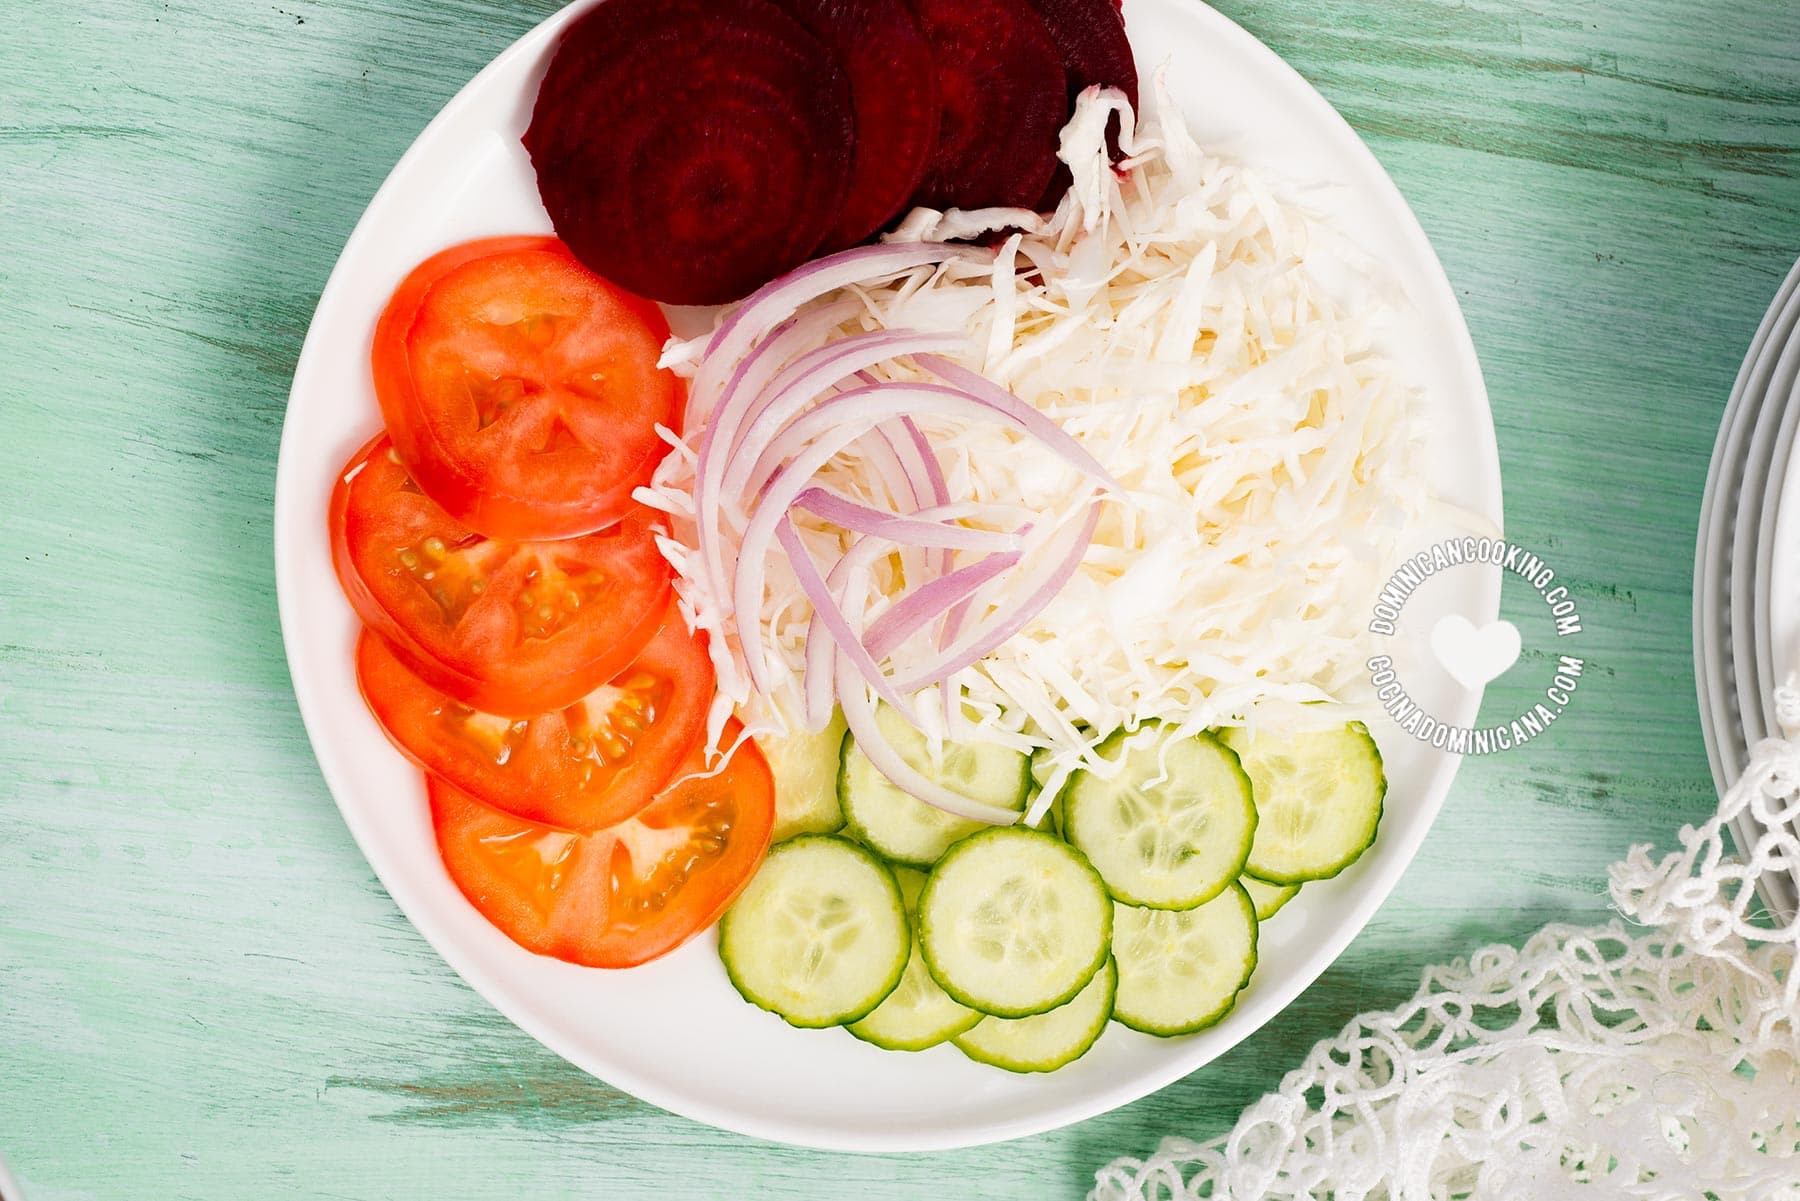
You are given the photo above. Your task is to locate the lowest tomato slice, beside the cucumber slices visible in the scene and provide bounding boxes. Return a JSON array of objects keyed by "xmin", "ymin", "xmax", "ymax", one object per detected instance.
[{"xmin": 427, "ymin": 731, "xmax": 776, "ymax": 967}]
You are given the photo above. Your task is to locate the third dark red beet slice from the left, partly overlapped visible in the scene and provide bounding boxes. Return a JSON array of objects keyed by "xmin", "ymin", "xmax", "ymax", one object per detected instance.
[{"xmin": 913, "ymin": 0, "xmax": 1069, "ymax": 209}]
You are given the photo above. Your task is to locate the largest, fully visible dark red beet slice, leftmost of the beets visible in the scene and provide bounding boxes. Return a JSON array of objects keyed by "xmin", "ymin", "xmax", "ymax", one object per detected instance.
[{"xmin": 524, "ymin": 0, "xmax": 855, "ymax": 304}]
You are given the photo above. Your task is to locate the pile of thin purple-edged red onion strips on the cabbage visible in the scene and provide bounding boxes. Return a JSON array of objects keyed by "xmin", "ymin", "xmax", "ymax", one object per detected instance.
[{"xmin": 688, "ymin": 252, "xmax": 1118, "ymax": 825}]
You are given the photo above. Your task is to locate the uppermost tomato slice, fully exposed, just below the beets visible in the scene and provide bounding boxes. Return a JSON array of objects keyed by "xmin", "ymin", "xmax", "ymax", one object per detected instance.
[{"xmin": 373, "ymin": 238, "xmax": 682, "ymax": 538}]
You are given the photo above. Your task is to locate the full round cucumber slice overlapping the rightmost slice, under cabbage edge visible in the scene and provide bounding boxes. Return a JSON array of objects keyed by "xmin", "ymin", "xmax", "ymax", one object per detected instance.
[{"xmin": 1064, "ymin": 724, "xmax": 1256, "ymax": 909}]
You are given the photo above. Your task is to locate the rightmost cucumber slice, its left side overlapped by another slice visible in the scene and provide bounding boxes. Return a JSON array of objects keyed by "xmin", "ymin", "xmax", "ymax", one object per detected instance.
[{"xmin": 1226, "ymin": 722, "xmax": 1388, "ymax": 884}]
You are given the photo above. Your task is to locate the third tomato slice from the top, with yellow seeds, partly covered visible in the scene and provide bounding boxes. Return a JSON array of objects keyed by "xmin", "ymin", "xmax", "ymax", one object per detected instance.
[{"xmin": 356, "ymin": 607, "xmax": 716, "ymax": 830}]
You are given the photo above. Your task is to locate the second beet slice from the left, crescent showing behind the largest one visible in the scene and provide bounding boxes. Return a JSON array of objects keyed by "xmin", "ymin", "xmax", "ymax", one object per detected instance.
[{"xmin": 776, "ymin": 0, "xmax": 938, "ymax": 250}]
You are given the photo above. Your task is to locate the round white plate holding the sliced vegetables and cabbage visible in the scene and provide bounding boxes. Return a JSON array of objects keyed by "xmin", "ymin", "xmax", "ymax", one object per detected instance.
[{"xmin": 275, "ymin": 0, "xmax": 1499, "ymax": 1151}]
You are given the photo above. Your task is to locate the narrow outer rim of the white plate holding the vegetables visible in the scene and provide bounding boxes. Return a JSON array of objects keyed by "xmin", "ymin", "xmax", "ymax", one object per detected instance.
[{"xmin": 274, "ymin": 0, "xmax": 1503, "ymax": 1152}]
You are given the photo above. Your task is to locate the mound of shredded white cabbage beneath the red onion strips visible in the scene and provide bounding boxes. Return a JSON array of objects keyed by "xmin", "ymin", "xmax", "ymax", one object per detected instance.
[{"xmin": 641, "ymin": 77, "xmax": 1426, "ymax": 806}]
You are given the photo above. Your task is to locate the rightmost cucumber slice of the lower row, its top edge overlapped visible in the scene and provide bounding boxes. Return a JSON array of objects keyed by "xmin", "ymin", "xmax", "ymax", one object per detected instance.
[{"xmin": 1112, "ymin": 884, "xmax": 1256, "ymax": 1035}]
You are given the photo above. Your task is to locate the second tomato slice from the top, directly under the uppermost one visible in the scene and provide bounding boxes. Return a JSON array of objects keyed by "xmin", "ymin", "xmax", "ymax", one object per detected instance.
[{"xmin": 331, "ymin": 436, "xmax": 670, "ymax": 717}]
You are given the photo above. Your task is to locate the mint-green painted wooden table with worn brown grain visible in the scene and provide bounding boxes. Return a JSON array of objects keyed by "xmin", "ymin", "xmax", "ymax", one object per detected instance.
[{"xmin": 0, "ymin": 0, "xmax": 1800, "ymax": 1201}]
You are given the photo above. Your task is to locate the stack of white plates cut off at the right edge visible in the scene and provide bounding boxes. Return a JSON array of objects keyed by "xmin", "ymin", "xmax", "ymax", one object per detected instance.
[{"xmin": 1694, "ymin": 255, "xmax": 1800, "ymax": 915}]
